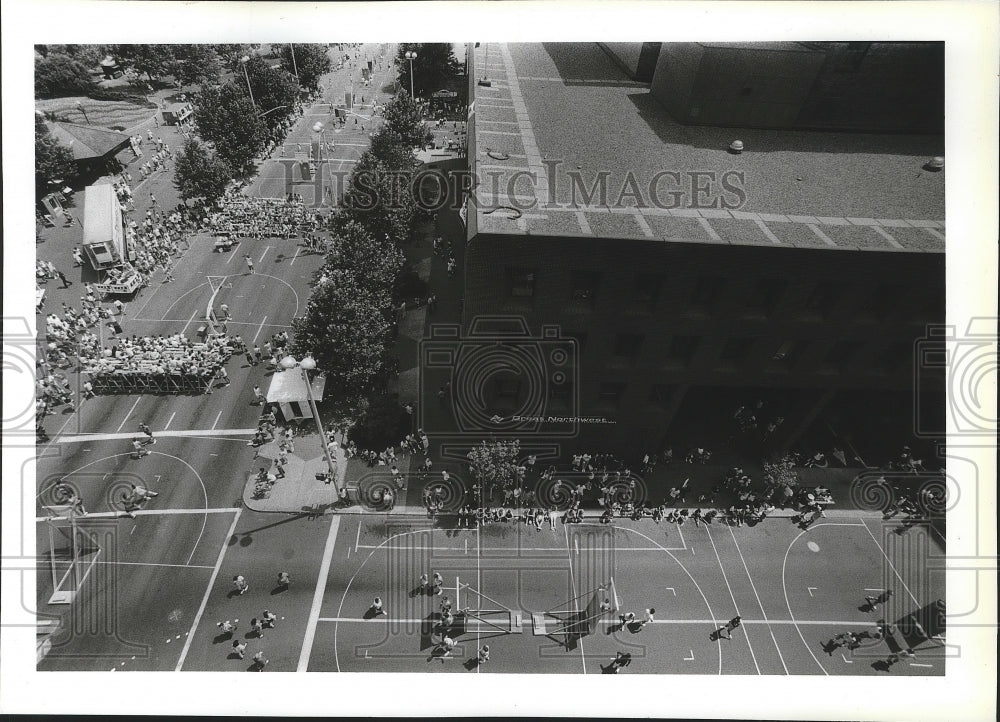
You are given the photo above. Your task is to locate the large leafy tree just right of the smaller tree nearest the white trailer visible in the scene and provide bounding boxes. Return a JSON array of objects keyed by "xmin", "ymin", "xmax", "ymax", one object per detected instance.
[{"xmin": 194, "ymin": 82, "xmax": 267, "ymax": 174}]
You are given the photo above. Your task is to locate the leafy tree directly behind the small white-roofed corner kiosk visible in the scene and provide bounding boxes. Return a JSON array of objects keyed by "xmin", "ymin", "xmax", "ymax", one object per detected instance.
[{"xmin": 291, "ymin": 269, "xmax": 391, "ymax": 400}]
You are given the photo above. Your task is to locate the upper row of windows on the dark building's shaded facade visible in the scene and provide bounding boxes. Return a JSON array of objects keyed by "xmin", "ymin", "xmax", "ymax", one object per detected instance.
[{"xmin": 507, "ymin": 268, "xmax": 943, "ymax": 320}]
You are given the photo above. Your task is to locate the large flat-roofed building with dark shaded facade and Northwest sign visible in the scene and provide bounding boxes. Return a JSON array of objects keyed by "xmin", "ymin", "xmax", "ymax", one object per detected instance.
[{"xmin": 463, "ymin": 43, "xmax": 945, "ymax": 452}]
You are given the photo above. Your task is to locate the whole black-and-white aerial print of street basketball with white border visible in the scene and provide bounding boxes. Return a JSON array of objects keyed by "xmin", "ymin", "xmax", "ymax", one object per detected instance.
[{"xmin": 3, "ymin": 2, "xmax": 997, "ymax": 719}]
